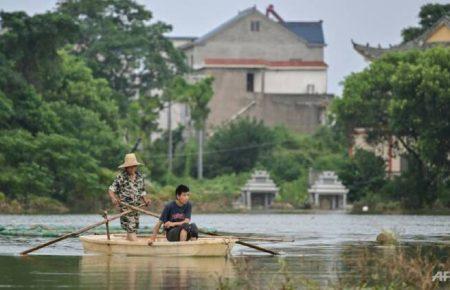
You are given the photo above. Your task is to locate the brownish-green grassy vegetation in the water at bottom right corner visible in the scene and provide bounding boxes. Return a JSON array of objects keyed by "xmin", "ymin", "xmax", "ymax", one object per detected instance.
[{"xmin": 336, "ymin": 245, "xmax": 450, "ymax": 289}]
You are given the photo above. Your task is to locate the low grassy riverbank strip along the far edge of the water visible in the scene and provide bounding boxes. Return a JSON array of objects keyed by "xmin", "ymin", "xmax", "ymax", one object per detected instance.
[{"xmin": 0, "ymin": 190, "xmax": 450, "ymax": 215}]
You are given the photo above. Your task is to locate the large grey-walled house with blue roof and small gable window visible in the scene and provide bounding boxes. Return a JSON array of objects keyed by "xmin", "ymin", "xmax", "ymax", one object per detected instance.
[{"xmin": 167, "ymin": 6, "xmax": 332, "ymax": 132}]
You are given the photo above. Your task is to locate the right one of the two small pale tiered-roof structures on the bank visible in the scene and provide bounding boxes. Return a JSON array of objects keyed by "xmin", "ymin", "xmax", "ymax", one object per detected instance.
[{"xmin": 308, "ymin": 171, "xmax": 348, "ymax": 209}]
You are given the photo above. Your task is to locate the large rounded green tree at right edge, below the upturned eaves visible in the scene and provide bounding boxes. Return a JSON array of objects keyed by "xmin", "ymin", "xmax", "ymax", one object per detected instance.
[{"xmin": 333, "ymin": 47, "xmax": 450, "ymax": 206}]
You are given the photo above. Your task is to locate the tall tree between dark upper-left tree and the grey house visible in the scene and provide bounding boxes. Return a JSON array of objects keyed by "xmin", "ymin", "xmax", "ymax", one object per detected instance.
[{"xmin": 57, "ymin": 0, "xmax": 186, "ymax": 145}]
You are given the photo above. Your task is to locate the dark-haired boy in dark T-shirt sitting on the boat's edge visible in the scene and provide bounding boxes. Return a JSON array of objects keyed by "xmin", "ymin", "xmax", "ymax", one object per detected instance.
[{"xmin": 148, "ymin": 184, "xmax": 198, "ymax": 245}]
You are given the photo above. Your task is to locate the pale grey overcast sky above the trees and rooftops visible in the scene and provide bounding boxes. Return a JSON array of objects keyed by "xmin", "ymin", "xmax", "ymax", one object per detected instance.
[{"xmin": 0, "ymin": 0, "xmax": 448, "ymax": 95}]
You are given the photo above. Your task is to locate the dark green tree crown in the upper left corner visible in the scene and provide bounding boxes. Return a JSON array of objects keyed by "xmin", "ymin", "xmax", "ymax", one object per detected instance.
[{"xmin": 0, "ymin": 11, "xmax": 78, "ymax": 93}]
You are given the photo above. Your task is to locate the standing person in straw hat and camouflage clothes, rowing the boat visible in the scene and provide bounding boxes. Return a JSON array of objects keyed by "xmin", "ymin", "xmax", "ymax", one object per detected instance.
[{"xmin": 108, "ymin": 153, "xmax": 151, "ymax": 241}]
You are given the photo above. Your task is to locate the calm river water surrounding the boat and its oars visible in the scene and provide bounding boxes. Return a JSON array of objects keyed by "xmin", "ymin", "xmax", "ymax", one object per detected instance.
[{"xmin": 0, "ymin": 212, "xmax": 450, "ymax": 289}]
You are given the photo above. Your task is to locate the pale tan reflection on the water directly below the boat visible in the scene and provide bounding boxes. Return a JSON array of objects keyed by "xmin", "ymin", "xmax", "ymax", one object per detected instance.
[{"xmin": 80, "ymin": 255, "xmax": 235, "ymax": 289}]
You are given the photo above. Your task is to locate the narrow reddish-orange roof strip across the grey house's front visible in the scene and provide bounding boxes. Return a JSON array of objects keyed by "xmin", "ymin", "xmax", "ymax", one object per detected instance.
[{"xmin": 205, "ymin": 58, "xmax": 328, "ymax": 68}]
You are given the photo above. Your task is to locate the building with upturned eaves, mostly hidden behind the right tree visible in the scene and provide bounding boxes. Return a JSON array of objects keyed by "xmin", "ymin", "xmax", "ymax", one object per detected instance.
[{"xmin": 350, "ymin": 16, "xmax": 450, "ymax": 176}]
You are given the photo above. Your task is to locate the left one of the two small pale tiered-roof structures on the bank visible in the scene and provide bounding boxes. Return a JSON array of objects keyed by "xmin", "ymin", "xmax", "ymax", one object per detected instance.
[{"xmin": 240, "ymin": 170, "xmax": 279, "ymax": 209}]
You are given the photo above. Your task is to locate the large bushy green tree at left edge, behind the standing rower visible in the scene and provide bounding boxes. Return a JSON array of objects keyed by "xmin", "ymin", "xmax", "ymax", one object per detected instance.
[{"xmin": 0, "ymin": 13, "xmax": 124, "ymax": 210}]
